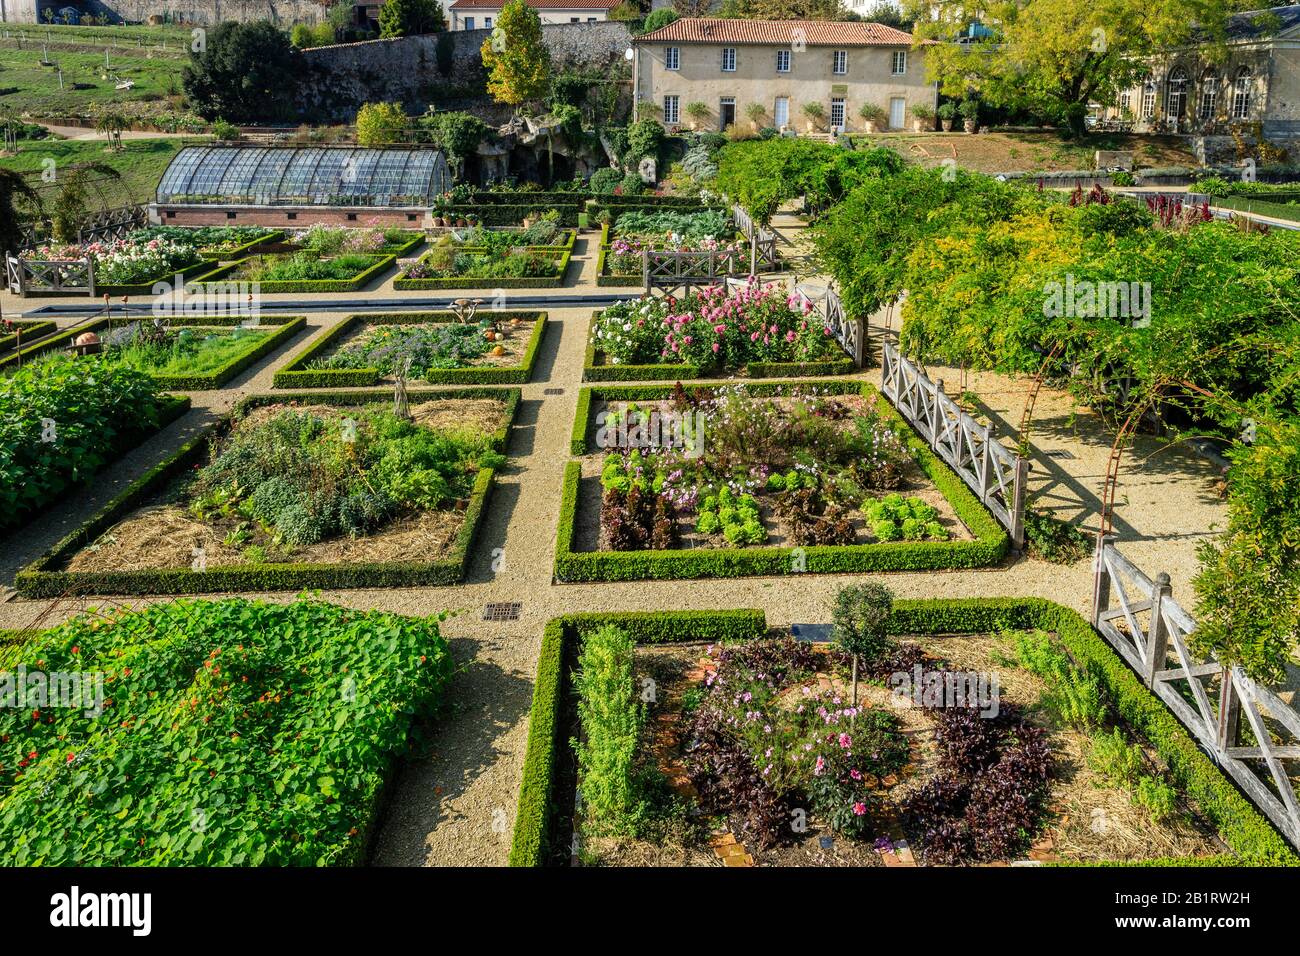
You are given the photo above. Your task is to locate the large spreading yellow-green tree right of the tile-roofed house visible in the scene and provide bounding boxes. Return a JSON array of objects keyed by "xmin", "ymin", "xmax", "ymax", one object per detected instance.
[{"xmin": 907, "ymin": 0, "xmax": 1234, "ymax": 135}]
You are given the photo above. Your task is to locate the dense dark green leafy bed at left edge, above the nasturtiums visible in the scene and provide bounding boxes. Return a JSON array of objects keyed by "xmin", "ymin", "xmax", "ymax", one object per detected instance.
[{"xmin": 0, "ymin": 356, "xmax": 190, "ymax": 529}]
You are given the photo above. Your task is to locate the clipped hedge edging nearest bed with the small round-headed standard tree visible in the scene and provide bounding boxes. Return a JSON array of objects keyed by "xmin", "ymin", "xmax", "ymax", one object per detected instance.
[{"xmin": 510, "ymin": 597, "xmax": 1300, "ymax": 868}]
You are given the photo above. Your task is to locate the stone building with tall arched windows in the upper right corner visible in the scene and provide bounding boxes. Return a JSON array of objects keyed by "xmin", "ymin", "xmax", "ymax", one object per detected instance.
[{"xmin": 1100, "ymin": 4, "xmax": 1300, "ymax": 163}]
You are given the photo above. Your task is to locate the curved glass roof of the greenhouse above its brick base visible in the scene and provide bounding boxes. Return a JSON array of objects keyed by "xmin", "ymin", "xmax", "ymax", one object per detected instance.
[{"xmin": 157, "ymin": 146, "xmax": 451, "ymax": 206}]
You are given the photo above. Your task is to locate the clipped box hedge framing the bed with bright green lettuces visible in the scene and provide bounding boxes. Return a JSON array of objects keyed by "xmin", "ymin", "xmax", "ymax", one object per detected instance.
[{"xmin": 555, "ymin": 381, "xmax": 1010, "ymax": 584}]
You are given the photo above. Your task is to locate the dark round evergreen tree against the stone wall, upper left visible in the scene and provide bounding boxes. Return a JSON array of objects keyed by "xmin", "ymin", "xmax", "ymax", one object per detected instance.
[{"xmin": 182, "ymin": 21, "xmax": 300, "ymax": 122}]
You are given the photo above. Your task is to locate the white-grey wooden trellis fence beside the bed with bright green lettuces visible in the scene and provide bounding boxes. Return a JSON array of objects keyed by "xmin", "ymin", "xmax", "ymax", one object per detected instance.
[{"xmin": 880, "ymin": 342, "xmax": 1030, "ymax": 549}]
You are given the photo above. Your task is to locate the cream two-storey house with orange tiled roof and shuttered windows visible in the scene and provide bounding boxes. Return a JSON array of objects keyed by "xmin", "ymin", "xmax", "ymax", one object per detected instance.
[{"xmin": 632, "ymin": 17, "xmax": 939, "ymax": 131}]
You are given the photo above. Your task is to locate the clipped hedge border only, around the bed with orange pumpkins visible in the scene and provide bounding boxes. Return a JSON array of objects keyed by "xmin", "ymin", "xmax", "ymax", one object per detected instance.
[{"xmin": 272, "ymin": 312, "xmax": 549, "ymax": 389}]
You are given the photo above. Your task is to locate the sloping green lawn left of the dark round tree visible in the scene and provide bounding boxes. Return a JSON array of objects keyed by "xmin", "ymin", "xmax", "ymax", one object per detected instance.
[{"xmin": 0, "ymin": 40, "xmax": 189, "ymax": 117}]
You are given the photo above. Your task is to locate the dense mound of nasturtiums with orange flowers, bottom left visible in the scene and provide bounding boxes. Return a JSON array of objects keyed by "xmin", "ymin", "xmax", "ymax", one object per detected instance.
[{"xmin": 0, "ymin": 598, "xmax": 452, "ymax": 866}]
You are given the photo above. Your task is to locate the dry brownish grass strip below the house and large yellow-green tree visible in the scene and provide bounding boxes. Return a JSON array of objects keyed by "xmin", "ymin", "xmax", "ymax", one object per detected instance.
[{"xmin": 853, "ymin": 130, "xmax": 1199, "ymax": 173}]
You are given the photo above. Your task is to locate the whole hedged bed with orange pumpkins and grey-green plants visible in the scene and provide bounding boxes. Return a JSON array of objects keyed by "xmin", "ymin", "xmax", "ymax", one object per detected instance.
[{"xmin": 273, "ymin": 312, "xmax": 546, "ymax": 389}]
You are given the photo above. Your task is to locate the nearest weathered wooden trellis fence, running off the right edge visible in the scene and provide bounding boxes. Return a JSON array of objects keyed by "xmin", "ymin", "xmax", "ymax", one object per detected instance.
[{"xmin": 1092, "ymin": 535, "xmax": 1300, "ymax": 849}]
